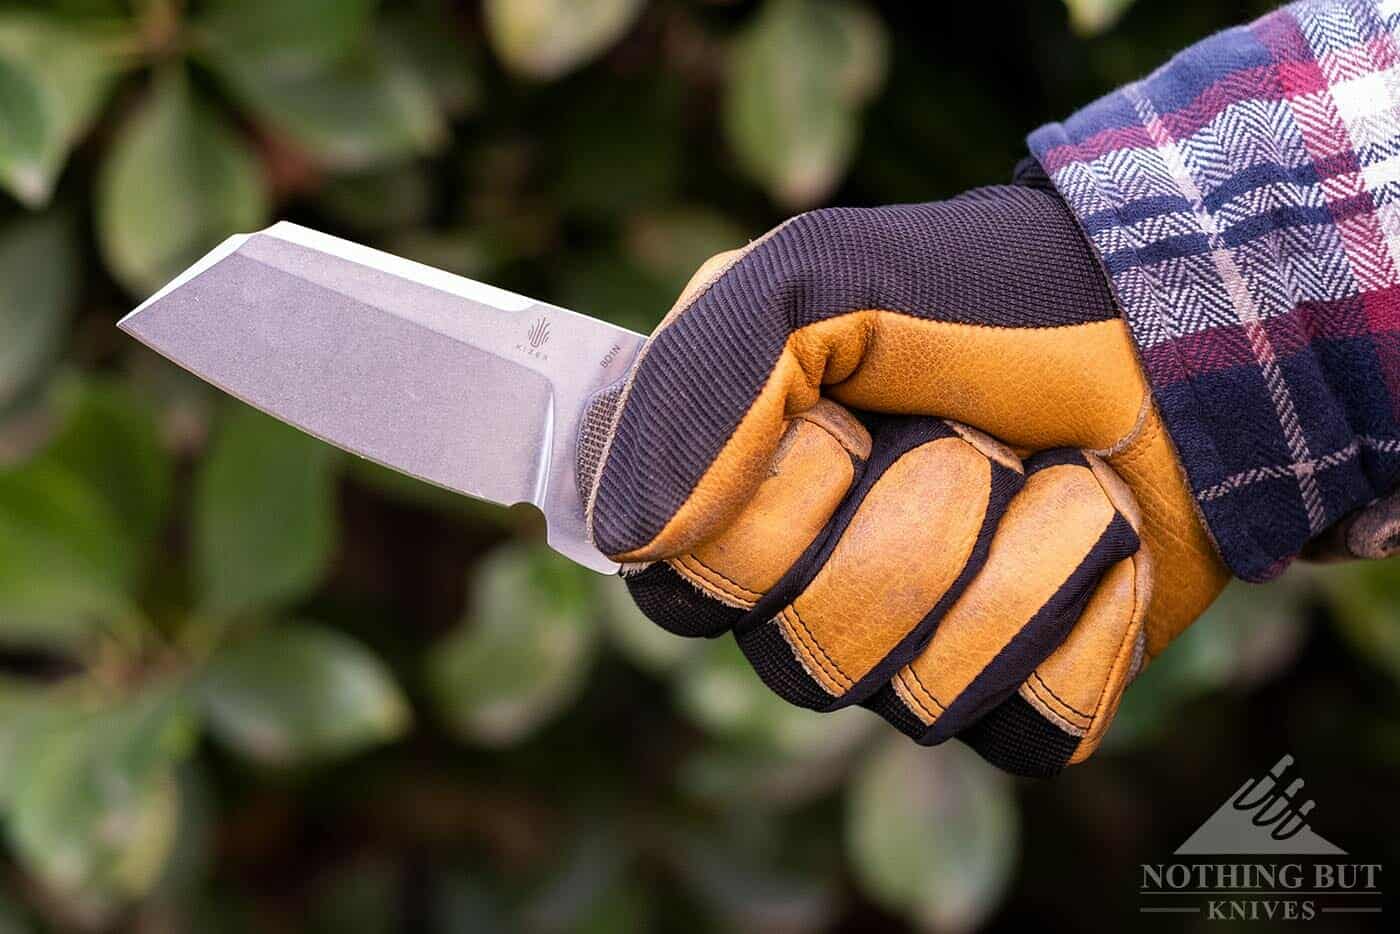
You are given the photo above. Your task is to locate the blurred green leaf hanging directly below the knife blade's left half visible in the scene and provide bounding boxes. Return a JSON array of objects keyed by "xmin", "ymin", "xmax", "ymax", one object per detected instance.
[{"xmin": 193, "ymin": 405, "xmax": 339, "ymax": 615}]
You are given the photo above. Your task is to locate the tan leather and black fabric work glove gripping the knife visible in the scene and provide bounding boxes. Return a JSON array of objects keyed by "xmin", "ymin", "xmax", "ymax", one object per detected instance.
[{"xmin": 581, "ymin": 179, "xmax": 1228, "ymax": 774}]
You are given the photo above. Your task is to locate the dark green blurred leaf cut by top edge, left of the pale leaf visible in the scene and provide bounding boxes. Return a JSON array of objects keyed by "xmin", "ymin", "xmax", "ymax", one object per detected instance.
[{"xmin": 196, "ymin": 0, "xmax": 378, "ymax": 73}]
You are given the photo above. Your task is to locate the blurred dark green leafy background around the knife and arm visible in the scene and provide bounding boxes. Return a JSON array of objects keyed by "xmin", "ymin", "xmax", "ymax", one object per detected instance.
[{"xmin": 0, "ymin": 0, "xmax": 1400, "ymax": 934}]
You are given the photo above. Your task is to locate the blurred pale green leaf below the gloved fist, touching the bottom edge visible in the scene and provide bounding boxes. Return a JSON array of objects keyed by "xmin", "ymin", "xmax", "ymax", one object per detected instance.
[{"xmin": 846, "ymin": 737, "xmax": 1018, "ymax": 934}]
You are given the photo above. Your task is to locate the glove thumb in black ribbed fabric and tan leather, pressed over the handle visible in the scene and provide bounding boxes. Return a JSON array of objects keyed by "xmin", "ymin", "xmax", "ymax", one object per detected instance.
[{"xmin": 588, "ymin": 189, "xmax": 1145, "ymax": 562}]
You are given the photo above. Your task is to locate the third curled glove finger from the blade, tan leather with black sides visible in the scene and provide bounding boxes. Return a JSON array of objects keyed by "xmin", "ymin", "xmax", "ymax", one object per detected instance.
[{"xmin": 868, "ymin": 449, "xmax": 1140, "ymax": 772}]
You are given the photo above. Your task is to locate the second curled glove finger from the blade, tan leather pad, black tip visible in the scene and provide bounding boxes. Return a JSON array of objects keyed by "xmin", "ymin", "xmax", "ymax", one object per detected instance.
[{"xmin": 735, "ymin": 417, "xmax": 1022, "ymax": 710}]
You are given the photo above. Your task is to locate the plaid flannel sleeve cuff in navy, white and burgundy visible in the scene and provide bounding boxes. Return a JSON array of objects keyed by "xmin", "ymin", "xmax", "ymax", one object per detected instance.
[{"xmin": 1029, "ymin": 0, "xmax": 1400, "ymax": 580}]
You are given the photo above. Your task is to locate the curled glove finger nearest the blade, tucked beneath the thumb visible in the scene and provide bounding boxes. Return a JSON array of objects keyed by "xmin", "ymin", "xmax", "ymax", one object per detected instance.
[{"xmin": 623, "ymin": 400, "xmax": 871, "ymax": 637}]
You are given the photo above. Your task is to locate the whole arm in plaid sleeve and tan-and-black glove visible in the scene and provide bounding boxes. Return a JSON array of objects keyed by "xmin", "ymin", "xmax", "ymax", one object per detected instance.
[{"xmin": 580, "ymin": 0, "xmax": 1400, "ymax": 774}]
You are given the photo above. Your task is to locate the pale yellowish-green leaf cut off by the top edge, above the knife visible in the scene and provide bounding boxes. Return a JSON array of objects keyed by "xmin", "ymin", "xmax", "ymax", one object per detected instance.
[{"xmin": 486, "ymin": 0, "xmax": 645, "ymax": 80}]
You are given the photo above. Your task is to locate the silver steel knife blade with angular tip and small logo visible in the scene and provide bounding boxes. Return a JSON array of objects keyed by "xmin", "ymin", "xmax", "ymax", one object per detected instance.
[{"xmin": 119, "ymin": 223, "xmax": 645, "ymax": 571}]
